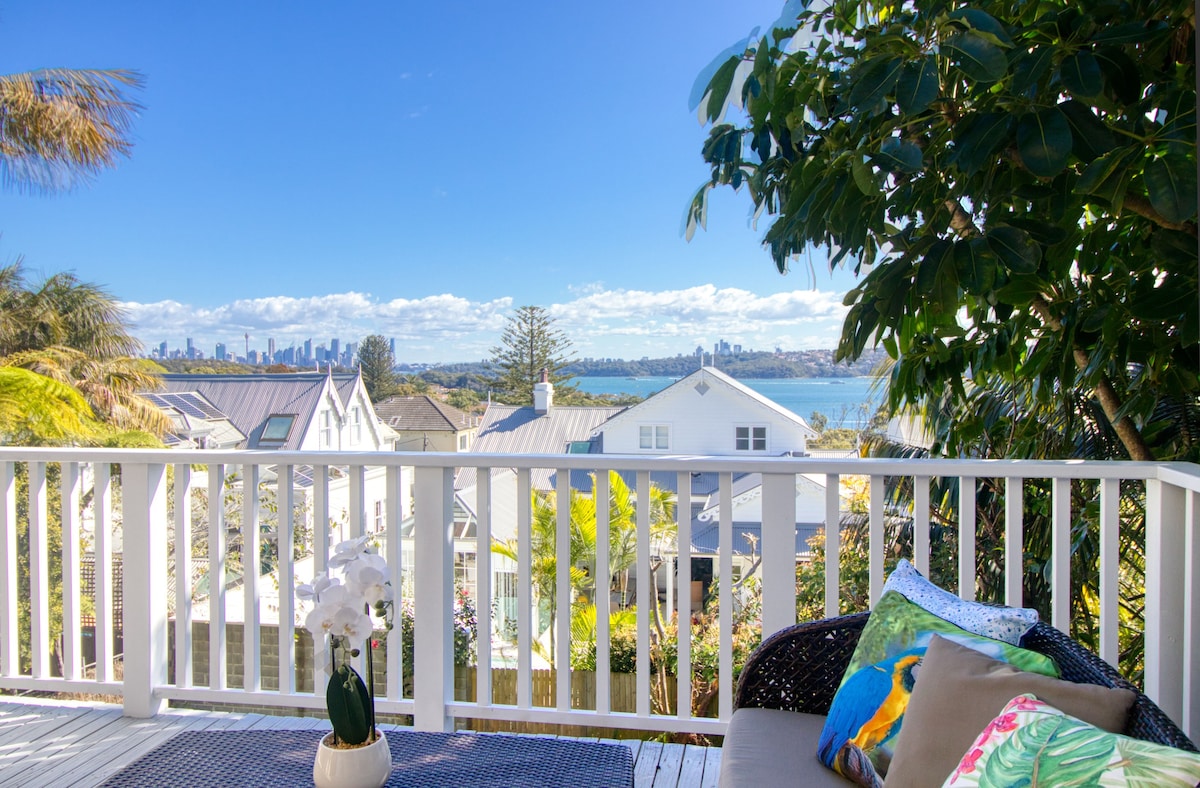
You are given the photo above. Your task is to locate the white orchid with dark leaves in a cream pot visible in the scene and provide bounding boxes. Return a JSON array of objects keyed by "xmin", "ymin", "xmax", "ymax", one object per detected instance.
[{"xmin": 296, "ymin": 536, "xmax": 392, "ymax": 788}]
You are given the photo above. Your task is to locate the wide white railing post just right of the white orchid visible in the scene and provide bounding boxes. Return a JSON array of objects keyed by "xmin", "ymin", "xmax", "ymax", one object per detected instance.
[{"xmin": 413, "ymin": 468, "xmax": 454, "ymax": 730}]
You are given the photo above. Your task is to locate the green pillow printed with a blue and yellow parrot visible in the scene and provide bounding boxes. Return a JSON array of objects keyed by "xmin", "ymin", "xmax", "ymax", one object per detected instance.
[{"xmin": 817, "ymin": 591, "xmax": 1058, "ymax": 788}]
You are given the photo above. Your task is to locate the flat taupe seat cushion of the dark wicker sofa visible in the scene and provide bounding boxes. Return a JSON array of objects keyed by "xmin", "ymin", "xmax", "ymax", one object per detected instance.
[{"xmin": 718, "ymin": 708, "xmax": 854, "ymax": 788}]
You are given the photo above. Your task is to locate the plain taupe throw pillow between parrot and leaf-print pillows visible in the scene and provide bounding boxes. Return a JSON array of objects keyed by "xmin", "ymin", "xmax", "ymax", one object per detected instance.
[{"xmin": 883, "ymin": 637, "xmax": 1135, "ymax": 788}]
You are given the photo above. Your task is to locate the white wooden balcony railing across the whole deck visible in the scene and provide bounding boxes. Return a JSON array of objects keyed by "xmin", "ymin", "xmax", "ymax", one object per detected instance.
[{"xmin": 0, "ymin": 449, "xmax": 1200, "ymax": 739}]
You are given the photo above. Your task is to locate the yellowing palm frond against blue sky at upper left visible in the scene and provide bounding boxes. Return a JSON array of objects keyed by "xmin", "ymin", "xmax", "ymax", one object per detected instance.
[{"xmin": 0, "ymin": 68, "xmax": 142, "ymax": 192}]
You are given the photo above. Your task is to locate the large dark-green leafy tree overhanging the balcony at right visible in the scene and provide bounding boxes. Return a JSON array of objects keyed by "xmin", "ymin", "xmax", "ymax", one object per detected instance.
[{"xmin": 689, "ymin": 0, "xmax": 1200, "ymax": 459}]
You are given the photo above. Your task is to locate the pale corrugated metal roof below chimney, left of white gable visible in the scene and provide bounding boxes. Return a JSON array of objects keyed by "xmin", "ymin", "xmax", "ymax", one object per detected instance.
[{"xmin": 455, "ymin": 404, "xmax": 624, "ymax": 489}]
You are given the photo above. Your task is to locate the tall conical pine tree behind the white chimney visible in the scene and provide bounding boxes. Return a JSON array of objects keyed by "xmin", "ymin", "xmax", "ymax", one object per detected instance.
[{"xmin": 491, "ymin": 306, "xmax": 575, "ymax": 405}]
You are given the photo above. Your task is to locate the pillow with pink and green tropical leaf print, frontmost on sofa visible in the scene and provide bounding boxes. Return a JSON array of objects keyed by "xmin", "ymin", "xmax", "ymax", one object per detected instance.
[{"xmin": 942, "ymin": 694, "xmax": 1200, "ymax": 788}]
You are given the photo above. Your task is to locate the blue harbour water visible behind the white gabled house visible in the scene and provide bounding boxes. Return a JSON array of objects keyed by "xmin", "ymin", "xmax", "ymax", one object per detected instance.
[{"xmin": 571, "ymin": 377, "xmax": 883, "ymax": 428}]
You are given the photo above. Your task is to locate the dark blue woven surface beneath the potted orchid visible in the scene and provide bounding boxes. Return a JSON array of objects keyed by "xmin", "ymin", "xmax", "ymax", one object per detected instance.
[{"xmin": 103, "ymin": 730, "xmax": 634, "ymax": 788}]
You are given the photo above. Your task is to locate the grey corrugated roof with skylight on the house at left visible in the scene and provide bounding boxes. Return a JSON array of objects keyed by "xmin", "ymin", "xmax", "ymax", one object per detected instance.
[{"xmin": 162, "ymin": 372, "xmax": 358, "ymax": 450}]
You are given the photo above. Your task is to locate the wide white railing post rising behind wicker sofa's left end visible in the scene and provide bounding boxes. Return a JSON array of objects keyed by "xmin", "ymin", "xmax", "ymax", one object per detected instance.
[{"xmin": 760, "ymin": 474, "xmax": 797, "ymax": 640}]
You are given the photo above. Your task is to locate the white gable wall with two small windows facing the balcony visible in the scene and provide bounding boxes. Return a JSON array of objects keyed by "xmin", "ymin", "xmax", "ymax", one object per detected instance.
[{"xmin": 600, "ymin": 367, "xmax": 816, "ymax": 456}]
